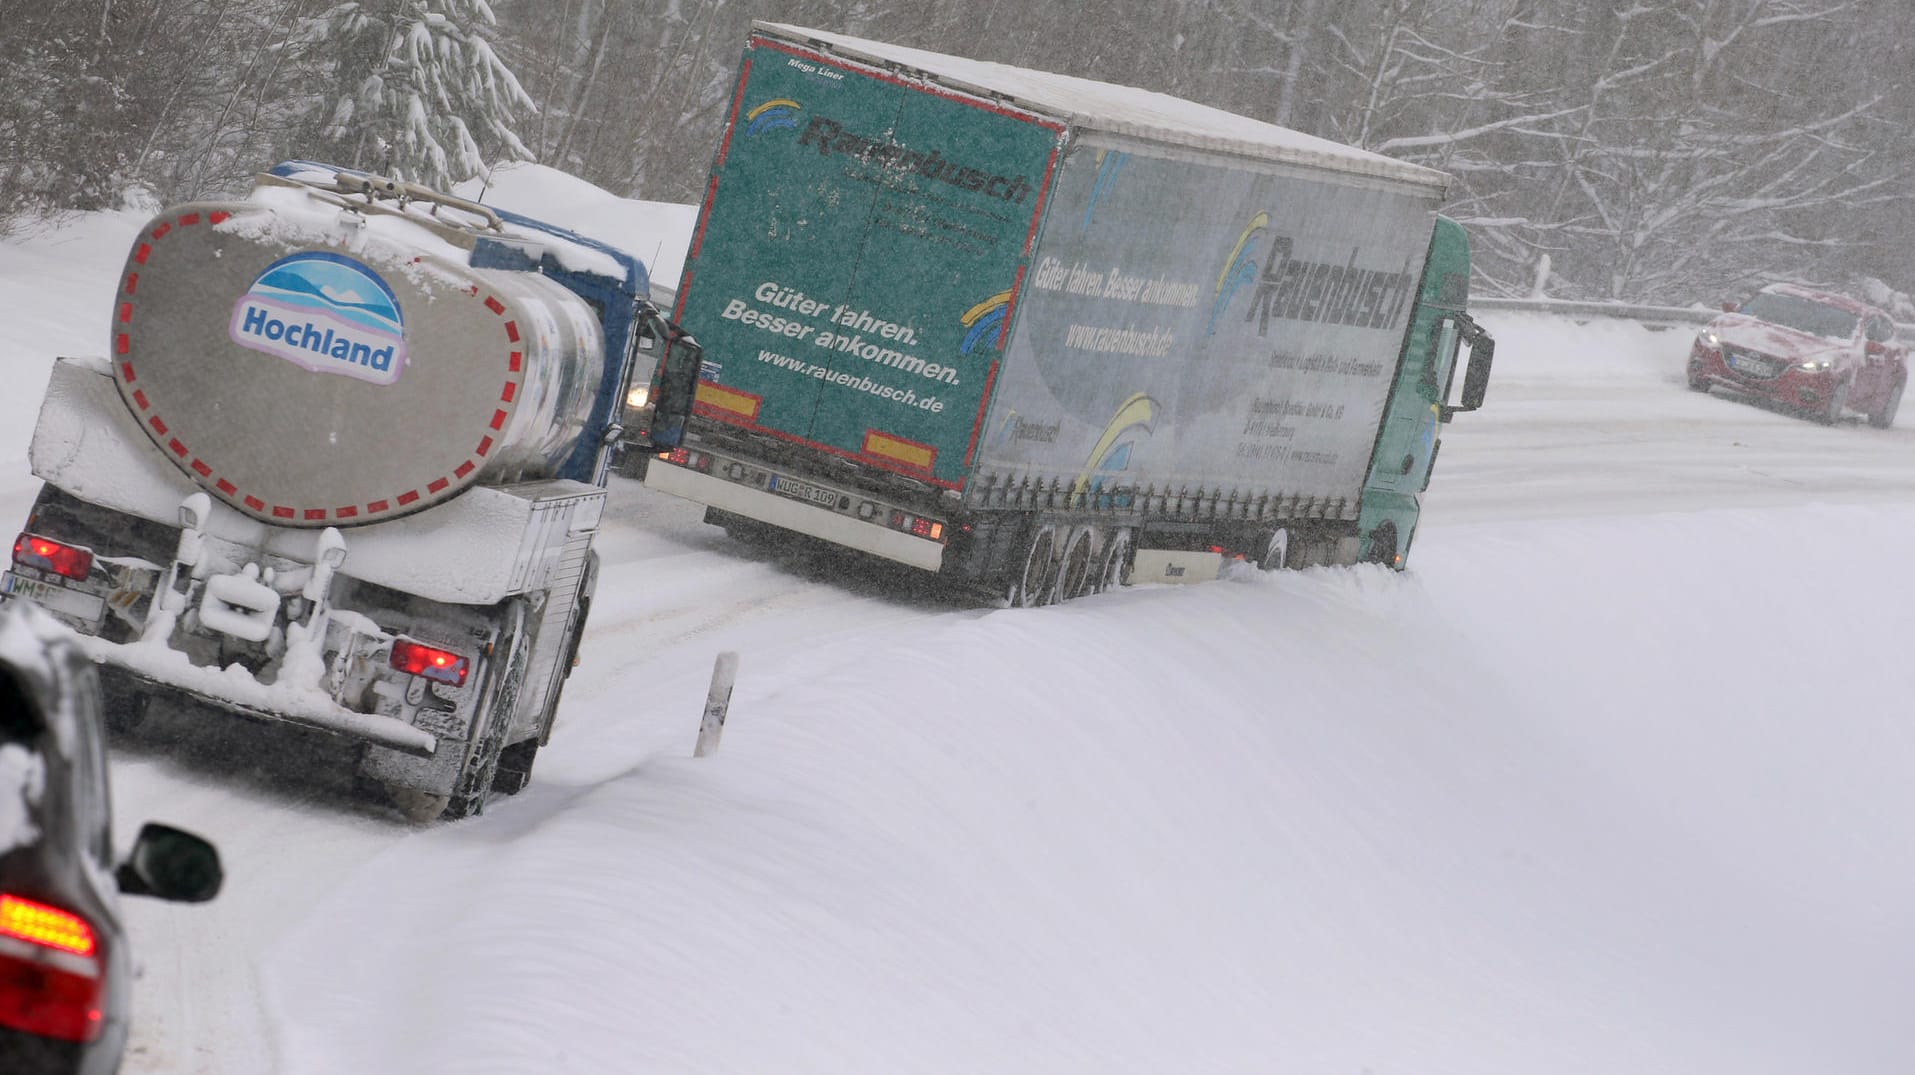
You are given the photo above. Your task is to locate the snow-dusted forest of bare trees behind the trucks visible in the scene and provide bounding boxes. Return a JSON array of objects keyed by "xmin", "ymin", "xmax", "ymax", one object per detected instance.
[{"xmin": 0, "ymin": 0, "xmax": 1915, "ymax": 303}]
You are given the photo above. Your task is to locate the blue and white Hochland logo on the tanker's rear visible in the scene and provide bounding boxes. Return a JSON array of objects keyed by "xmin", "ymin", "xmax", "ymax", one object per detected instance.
[{"xmin": 226, "ymin": 253, "xmax": 406, "ymax": 385}]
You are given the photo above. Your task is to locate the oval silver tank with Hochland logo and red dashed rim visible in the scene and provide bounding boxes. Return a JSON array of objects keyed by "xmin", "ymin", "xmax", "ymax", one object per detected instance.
[{"xmin": 111, "ymin": 172, "xmax": 605, "ymax": 527}]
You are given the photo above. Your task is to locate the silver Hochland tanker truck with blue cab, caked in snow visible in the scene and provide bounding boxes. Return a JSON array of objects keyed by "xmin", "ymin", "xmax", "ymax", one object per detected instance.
[{"xmin": 0, "ymin": 161, "xmax": 699, "ymax": 818}]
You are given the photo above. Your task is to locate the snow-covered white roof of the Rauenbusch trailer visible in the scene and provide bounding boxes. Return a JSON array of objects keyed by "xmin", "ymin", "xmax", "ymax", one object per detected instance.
[{"xmin": 753, "ymin": 21, "xmax": 1450, "ymax": 192}]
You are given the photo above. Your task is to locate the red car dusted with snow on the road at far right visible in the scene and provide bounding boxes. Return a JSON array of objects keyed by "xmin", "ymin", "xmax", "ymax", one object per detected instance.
[{"xmin": 1689, "ymin": 284, "xmax": 1909, "ymax": 429}]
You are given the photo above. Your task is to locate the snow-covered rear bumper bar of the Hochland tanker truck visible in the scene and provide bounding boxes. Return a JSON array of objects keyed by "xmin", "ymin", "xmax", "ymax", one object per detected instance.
[{"xmin": 75, "ymin": 634, "xmax": 439, "ymax": 757}]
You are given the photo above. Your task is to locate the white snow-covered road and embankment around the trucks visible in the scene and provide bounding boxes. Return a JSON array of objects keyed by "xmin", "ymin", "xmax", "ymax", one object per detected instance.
[{"xmin": 0, "ymin": 178, "xmax": 1915, "ymax": 1075}]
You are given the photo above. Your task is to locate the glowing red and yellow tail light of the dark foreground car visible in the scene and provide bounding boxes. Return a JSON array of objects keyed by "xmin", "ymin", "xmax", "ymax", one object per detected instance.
[{"xmin": 0, "ymin": 895, "xmax": 105, "ymax": 1041}]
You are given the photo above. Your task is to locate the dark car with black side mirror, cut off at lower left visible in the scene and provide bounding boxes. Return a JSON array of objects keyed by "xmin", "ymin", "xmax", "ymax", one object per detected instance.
[{"xmin": 0, "ymin": 602, "xmax": 220, "ymax": 1075}]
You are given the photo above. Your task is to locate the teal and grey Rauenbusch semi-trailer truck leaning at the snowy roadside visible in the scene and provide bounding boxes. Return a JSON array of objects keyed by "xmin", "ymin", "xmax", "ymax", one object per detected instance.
[{"xmin": 632, "ymin": 23, "xmax": 1494, "ymax": 606}]
